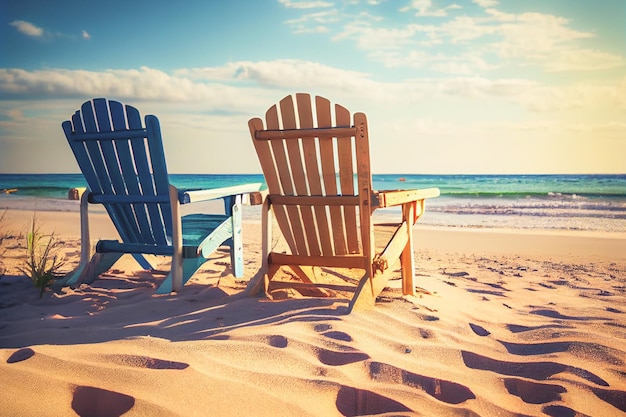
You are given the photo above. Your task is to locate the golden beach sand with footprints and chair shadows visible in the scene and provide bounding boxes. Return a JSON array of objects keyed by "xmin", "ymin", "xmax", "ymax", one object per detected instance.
[{"xmin": 0, "ymin": 206, "xmax": 626, "ymax": 417}]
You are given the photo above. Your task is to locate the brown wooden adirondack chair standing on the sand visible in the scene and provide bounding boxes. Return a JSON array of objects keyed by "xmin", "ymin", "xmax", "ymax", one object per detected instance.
[{"xmin": 246, "ymin": 94, "xmax": 439, "ymax": 311}]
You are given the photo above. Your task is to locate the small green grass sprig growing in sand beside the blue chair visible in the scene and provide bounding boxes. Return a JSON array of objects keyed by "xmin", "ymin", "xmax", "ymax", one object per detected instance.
[{"xmin": 19, "ymin": 215, "xmax": 63, "ymax": 298}]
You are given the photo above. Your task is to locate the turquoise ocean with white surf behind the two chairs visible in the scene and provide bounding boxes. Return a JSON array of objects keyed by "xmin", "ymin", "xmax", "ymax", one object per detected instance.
[{"xmin": 0, "ymin": 174, "xmax": 626, "ymax": 234}]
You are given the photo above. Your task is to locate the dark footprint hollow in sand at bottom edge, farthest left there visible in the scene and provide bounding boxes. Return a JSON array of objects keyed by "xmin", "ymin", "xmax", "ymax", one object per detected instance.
[{"xmin": 72, "ymin": 386, "xmax": 135, "ymax": 417}]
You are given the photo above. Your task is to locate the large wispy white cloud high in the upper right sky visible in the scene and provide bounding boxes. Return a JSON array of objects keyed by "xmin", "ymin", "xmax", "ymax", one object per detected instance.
[{"xmin": 286, "ymin": 0, "xmax": 626, "ymax": 75}]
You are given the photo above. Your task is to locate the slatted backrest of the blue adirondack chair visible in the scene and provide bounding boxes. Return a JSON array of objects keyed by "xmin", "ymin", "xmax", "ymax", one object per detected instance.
[{"xmin": 63, "ymin": 98, "xmax": 173, "ymax": 255}]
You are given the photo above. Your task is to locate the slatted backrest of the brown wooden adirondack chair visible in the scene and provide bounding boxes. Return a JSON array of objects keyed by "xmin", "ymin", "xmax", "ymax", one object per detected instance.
[{"xmin": 250, "ymin": 94, "xmax": 371, "ymax": 256}]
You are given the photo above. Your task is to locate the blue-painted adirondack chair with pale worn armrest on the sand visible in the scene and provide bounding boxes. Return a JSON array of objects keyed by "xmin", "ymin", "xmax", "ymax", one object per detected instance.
[{"xmin": 62, "ymin": 98, "xmax": 261, "ymax": 293}]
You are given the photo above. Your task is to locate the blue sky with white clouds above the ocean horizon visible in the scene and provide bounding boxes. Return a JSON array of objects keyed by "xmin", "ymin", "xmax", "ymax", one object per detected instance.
[{"xmin": 0, "ymin": 0, "xmax": 626, "ymax": 174}]
